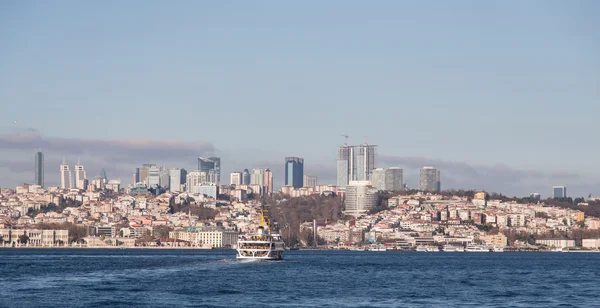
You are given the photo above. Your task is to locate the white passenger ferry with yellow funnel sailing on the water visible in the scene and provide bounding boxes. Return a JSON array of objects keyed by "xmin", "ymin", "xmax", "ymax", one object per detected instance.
[{"xmin": 235, "ymin": 210, "xmax": 285, "ymax": 260}]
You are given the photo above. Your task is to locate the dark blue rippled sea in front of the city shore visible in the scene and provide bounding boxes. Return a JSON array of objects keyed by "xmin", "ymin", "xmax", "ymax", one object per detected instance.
[{"xmin": 0, "ymin": 249, "xmax": 600, "ymax": 308}]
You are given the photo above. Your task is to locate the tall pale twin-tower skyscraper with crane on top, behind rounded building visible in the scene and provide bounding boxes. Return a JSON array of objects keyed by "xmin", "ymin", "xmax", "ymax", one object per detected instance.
[{"xmin": 337, "ymin": 144, "xmax": 377, "ymax": 186}]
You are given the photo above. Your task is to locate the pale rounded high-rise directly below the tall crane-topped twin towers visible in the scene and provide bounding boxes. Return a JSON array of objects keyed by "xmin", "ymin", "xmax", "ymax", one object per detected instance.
[{"xmin": 344, "ymin": 181, "xmax": 378, "ymax": 216}]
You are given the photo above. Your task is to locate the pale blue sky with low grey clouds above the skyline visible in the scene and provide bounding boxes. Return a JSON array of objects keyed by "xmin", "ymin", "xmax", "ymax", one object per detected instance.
[{"xmin": 0, "ymin": 0, "xmax": 600, "ymax": 197}]
